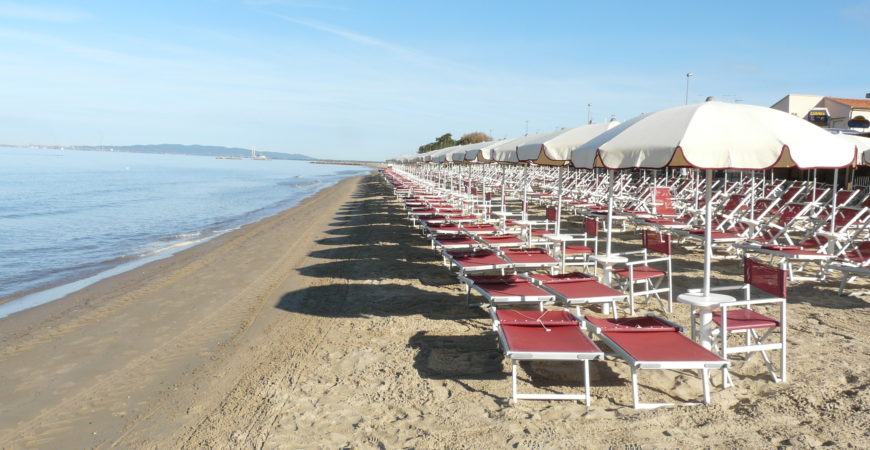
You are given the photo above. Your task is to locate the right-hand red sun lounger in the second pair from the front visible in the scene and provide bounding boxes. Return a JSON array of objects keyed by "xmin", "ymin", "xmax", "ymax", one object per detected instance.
[{"xmin": 529, "ymin": 272, "xmax": 628, "ymax": 318}]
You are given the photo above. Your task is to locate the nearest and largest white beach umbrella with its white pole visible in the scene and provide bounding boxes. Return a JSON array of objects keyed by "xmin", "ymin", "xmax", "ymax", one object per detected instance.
[{"xmin": 571, "ymin": 100, "xmax": 856, "ymax": 296}]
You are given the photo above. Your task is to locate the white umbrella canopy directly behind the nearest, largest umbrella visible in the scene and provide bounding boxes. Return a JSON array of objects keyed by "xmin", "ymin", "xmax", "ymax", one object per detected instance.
[{"xmin": 517, "ymin": 120, "xmax": 619, "ymax": 166}]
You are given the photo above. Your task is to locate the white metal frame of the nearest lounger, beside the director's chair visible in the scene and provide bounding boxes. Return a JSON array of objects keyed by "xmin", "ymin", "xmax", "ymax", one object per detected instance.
[{"xmin": 583, "ymin": 314, "xmax": 730, "ymax": 409}]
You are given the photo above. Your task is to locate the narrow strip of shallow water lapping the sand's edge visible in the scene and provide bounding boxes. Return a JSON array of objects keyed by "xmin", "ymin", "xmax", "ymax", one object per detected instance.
[{"xmin": 0, "ymin": 175, "xmax": 365, "ymax": 320}]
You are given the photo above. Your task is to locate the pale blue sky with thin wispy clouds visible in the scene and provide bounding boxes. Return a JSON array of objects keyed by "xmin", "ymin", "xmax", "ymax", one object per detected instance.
[{"xmin": 0, "ymin": 0, "xmax": 870, "ymax": 160}]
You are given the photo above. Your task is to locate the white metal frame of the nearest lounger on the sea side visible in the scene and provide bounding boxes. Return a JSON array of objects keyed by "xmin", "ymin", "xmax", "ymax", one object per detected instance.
[{"xmin": 490, "ymin": 308, "xmax": 604, "ymax": 408}]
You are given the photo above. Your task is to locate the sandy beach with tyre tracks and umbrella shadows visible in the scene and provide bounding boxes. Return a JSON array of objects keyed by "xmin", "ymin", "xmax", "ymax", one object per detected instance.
[{"xmin": 0, "ymin": 171, "xmax": 870, "ymax": 449}]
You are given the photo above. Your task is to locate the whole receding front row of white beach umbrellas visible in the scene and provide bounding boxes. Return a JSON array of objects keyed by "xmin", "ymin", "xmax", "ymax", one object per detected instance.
[{"xmin": 388, "ymin": 100, "xmax": 870, "ymax": 296}]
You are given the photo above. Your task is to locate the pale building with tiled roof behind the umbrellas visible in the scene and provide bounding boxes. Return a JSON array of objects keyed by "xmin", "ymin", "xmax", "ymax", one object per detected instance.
[{"xmin": 771, "ymin": 93, "xmax": 870, "ymax": 133}]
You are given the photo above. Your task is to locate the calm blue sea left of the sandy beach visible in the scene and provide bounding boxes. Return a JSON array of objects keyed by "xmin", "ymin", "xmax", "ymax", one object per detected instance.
[{"xmin": 0, "ymin": 147, "xmax": 371, "ymax": 318}]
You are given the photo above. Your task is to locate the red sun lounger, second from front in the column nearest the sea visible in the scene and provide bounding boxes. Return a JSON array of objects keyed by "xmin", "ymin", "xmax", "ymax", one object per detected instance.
[{"xmin": 459, "ymin": 275, "xmax": 555, "ymax": 310}]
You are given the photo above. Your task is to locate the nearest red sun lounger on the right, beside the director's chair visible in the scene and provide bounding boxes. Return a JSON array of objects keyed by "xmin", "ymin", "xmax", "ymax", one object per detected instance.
[{"xmin": 584, "ymin": 316, "xmax": 729, "ymax": 409}]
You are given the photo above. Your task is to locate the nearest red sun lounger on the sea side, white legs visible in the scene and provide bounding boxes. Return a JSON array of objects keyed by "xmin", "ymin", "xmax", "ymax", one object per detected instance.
[{"xmin": 490, "ymin": 308, "xmax": 604, "ymax": 407}]
